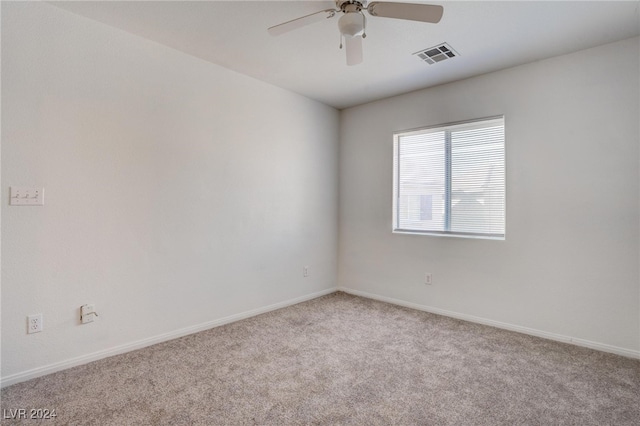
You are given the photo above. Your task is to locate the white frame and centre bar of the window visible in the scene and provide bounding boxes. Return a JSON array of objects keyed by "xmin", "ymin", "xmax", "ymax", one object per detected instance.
[{"xmin": 392, "ymin": 115, "xmax": 507, "ymax": 241}]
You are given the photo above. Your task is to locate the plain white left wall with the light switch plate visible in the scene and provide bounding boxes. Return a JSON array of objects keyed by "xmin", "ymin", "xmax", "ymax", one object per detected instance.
[{"xmin": 2, "ymin": 2, "xmax": 339, "ymax": 384}]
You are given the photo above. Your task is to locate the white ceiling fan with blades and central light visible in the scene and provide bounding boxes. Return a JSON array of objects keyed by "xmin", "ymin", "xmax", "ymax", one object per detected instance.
[{"xmin": 267, "ymin": 0, "xmax": 444, "ymax": 65}]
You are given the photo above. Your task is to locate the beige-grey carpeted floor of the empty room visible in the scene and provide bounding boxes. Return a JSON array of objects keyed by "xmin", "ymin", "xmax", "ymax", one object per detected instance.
[{"xmin": 1, "ymin": 293, "xmax": 640, "ymax": 425}]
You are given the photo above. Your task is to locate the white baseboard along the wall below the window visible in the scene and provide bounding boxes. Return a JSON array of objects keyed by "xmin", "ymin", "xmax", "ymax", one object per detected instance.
[{"xmin": 338, "ymin": 287, "xmax": 640, "ymax": 359}]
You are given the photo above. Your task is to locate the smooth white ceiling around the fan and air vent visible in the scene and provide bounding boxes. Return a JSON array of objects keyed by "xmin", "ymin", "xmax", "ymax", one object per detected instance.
[{"xmin": 54, "ymin": 0, "xmax": 640, "ymax": 108}]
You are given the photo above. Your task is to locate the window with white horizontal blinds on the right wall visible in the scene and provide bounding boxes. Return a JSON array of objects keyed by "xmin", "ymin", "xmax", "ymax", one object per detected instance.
[{"xmin": 393, "ymin": 117, "xmax": 505, "ymax": 239}]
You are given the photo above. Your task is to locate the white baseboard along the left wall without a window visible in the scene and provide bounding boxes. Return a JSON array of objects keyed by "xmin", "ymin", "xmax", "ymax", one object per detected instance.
[{"xmin": 0, "ymin": 287, "xmax": 338, "ymax": 388}]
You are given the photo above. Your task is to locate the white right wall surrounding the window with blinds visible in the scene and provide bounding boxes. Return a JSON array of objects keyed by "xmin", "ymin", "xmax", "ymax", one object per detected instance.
[{"xmin": 338, "ymin": 38, "xmax": 640, "ymax": 356}]
